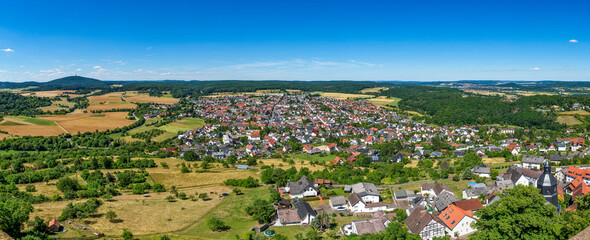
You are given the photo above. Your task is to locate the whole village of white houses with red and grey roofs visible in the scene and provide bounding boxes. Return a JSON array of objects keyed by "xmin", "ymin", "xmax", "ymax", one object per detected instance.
[{"xmin": 169, "ymin": 93, "xmax": 590, "ymax": 239}]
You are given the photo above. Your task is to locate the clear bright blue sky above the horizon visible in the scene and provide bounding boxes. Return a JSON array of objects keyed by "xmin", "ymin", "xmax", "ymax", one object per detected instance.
[{"xmin": 0, "ymin": 0, "xmax": 590, "ymax": 82}]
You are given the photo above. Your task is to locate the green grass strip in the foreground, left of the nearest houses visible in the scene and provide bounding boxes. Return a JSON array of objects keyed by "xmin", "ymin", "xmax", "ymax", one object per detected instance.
[{"xmin": 177, "ymin": 187, "xmax": 270, "ymax": 239}]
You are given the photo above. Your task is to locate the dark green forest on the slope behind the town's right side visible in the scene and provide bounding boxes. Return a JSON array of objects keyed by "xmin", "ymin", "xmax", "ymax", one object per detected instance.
[{"xmin": 381, "ymin": 86, "xmax": 590, "ymax": 130}]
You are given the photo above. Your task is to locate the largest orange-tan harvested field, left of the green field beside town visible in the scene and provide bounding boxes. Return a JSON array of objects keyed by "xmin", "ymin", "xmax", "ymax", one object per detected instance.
[{"xmin": 42, "ymin": 112, "xmax": 135, "ymax": 134}]
